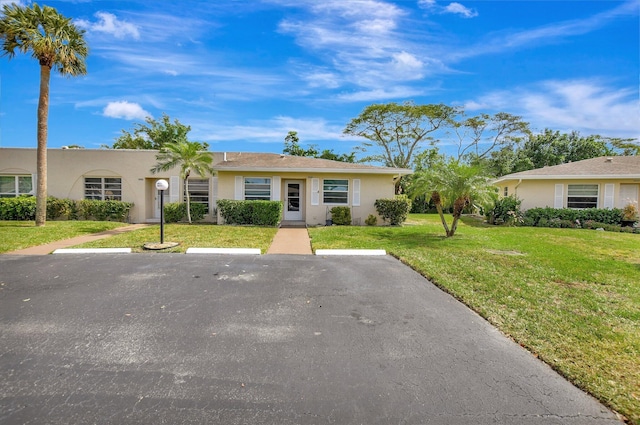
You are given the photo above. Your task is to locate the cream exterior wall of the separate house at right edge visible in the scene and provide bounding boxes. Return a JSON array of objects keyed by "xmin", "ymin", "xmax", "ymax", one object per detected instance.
[{"xmin": 498, "ymin": 179, "xmax": 640, "ymax": 210}]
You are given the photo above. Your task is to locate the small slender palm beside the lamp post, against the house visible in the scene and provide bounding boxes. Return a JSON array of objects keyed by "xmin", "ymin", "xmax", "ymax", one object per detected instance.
[{"xmin": 151, "ymin": 140, "xmax": 213, "ymax": 223}]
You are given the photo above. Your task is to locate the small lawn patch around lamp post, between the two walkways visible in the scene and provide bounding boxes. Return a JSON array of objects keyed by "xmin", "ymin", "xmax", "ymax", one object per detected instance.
[{"xmin": 74, "ymin": 224, "xmax": 278, "ymax": 254}]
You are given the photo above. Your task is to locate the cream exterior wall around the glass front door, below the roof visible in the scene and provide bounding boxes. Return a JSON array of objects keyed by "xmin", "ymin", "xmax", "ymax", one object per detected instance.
[{"xmin": 218, "ymin": 171, "xmax": 395, "ymax": 226}]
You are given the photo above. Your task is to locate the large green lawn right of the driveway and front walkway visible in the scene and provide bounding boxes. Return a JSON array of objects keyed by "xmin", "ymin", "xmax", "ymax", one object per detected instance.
[{"xmin": 310, "ymin": 215, "xmax": 640, "ymax": 424}]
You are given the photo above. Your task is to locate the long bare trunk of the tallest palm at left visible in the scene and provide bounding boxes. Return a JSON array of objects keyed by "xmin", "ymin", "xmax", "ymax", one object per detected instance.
[{"xmin": 36, "ymin": 65, "xmax": 51, "ymax": 226}]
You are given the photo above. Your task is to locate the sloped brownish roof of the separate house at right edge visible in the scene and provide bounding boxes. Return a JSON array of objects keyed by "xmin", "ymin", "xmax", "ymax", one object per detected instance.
[{"xmin": 495, "ymin": 156, "xmax": 640, "ymax": 183}]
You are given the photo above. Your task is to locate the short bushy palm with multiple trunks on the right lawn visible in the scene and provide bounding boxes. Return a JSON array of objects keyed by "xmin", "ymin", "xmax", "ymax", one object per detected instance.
[{"xmin": 409, "ymin": 160, "xmax": 495, "ymax": 237}]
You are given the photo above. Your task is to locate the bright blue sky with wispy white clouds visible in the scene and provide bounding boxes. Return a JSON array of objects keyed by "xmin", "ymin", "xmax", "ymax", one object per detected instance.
[{"xmin": 0, "ymin": 0, "xmax": 640, "ymax": 157}]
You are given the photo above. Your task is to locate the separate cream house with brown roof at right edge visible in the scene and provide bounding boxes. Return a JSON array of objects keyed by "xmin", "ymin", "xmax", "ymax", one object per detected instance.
[{"xmin": 494, "ymin": 156, "xmax": 640, "ymax": 210}]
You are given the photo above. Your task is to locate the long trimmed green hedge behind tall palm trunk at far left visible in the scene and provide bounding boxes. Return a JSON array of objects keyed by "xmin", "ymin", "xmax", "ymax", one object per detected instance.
[{"xmin": 0, "ymin": 196, "xmax": 133, "ymax": 222}]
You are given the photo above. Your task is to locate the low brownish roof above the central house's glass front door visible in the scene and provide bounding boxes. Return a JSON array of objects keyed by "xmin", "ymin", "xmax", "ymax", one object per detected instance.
[{"xmin": 213, "ymin": 152, "xmax": 413, "ymax": 175}]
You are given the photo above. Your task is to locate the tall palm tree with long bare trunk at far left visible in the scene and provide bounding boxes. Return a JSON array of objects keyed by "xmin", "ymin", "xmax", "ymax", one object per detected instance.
[{"xmin": 0, "ymin": 3, "xmax": 89, "ymax": 226}]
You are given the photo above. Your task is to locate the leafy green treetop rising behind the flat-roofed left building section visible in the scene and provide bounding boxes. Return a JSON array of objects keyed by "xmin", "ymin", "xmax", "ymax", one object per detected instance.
[{"xmin": 105, "ymin": 114, "xmax": 209, "ymax": 150}]
